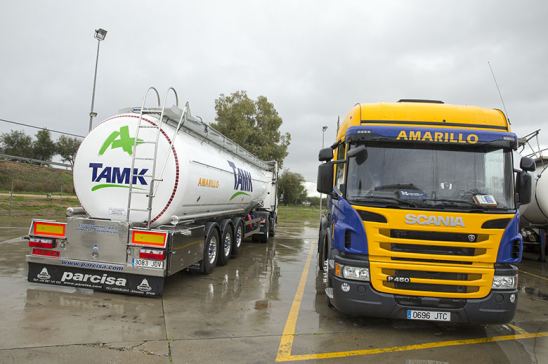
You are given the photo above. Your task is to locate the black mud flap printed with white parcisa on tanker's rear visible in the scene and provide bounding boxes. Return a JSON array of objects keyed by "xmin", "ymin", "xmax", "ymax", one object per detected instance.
[{"xmin": 28, "ymin": 262, "xmax": 164, "ymax": 297}]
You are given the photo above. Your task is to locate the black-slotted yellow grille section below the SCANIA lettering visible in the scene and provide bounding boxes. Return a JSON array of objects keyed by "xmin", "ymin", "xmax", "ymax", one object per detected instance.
[{"xmin": 371, "ymin": 229, "xmax": 493, "ymax": 298}]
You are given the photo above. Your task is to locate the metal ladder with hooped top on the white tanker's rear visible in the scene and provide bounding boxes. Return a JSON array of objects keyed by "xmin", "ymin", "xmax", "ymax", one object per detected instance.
[{"xmin": 126, "ymin": 87, "xmax": 180, "ymax": 229}]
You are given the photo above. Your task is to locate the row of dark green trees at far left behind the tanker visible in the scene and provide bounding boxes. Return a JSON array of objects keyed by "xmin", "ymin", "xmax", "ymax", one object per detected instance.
[{"xmin": 0, "ymin": 129, "xmax": 81, "ymax": 166}]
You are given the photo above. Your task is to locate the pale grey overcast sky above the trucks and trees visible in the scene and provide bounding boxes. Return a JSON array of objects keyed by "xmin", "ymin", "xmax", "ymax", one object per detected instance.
[{"xmin": 0, "ymin": 0, "xmax": 548, "ymax": 181}]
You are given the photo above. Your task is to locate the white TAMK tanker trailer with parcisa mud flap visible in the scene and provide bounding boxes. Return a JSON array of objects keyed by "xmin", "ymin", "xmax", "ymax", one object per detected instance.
[{"xmin": 27, "ymin": 90, "xmax": 277, "ymax": 296}]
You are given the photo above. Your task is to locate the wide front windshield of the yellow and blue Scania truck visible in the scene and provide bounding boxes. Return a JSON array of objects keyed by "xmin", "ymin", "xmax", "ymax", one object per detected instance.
[{"xmin": 346, "ymin": 144, "xmax": 514, "ymax": 210}]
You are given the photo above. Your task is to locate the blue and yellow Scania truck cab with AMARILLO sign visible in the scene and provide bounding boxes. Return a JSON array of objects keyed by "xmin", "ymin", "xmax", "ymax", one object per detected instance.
[{"xmin": 318, "ymin": 100, "xmax": 534, "ymax": 323}]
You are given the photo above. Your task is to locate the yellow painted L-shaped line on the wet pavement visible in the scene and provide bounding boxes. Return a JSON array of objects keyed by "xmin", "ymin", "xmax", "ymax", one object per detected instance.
[{"xmin": 276, "ymin": 244, "xmax": 548, "ymax": 362}]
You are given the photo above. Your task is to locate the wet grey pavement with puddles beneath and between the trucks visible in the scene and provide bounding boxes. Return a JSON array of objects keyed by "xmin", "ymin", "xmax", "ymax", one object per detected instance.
[{"xmin": 0, "ymin": 218, "xmax": 548, "ymax": 364}]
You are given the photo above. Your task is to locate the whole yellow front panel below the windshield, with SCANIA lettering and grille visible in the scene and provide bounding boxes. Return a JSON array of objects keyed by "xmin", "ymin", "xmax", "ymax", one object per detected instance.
[{"xmin": 357, "ymin": 206, "xmax": 519, "ymax": 298}]
